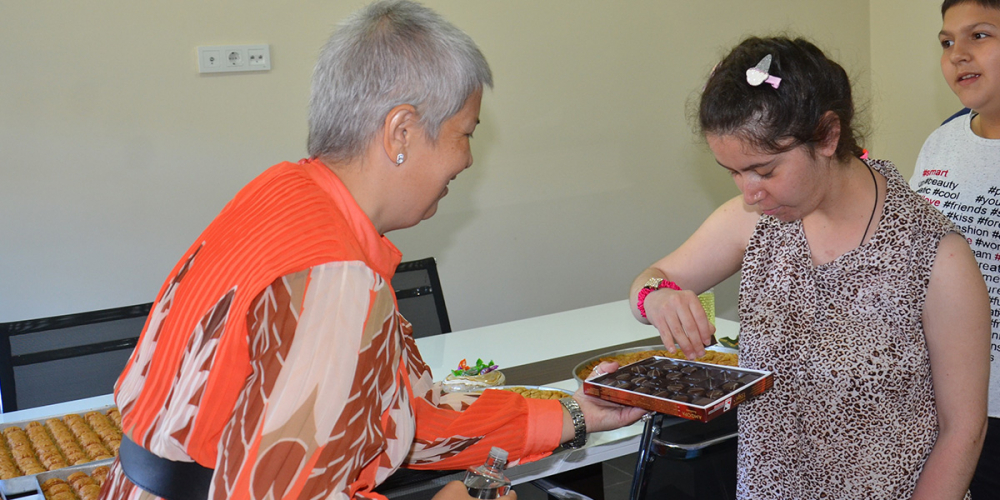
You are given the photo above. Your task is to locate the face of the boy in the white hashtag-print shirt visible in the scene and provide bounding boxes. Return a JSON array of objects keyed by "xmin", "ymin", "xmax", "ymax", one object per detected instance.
[{"xmin": 938, "ymin": 2, "xmax": 1000, "ymax": 117}]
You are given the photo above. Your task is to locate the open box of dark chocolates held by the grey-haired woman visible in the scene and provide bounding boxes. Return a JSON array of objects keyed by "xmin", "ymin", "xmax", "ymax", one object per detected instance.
[{"xmin": 583, "ymin": 356, "xmax": 774, "ymax": 422}]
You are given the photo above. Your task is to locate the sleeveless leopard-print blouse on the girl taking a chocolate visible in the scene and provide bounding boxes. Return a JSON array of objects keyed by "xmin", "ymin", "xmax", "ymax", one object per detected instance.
[{"xmin": 737, "ymin": 160, "xmax": 969, "ymax": 500}]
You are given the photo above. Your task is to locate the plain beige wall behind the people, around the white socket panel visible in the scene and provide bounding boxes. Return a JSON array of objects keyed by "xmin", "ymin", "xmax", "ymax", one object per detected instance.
[{"xmin": 0, "ymin": 0, "xmax": 928, "ymax": 329}]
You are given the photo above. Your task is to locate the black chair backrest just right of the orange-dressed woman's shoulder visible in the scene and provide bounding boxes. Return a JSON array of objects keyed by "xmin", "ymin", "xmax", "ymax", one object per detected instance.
[{"xmin": 392, "ymin": 257, "xmax": 451, "ymax": 338}]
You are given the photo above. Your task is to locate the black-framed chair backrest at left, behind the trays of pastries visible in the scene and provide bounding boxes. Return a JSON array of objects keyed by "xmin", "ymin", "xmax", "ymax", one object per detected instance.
[{"xmin": 0, "ymin": 303, "xmax": 153, "ymax": 413}]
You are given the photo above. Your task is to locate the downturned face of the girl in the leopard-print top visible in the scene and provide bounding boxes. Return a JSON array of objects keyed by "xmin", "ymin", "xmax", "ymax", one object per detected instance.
[{"xmin": 705, "ymin": 134, "xmax": 829, "ymax": 222}]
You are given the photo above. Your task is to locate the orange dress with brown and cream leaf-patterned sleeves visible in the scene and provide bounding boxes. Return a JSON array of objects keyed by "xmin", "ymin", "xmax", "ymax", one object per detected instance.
[{"xmin": 102, "ymin": 160, "xmax": 562, "ymax": 500}]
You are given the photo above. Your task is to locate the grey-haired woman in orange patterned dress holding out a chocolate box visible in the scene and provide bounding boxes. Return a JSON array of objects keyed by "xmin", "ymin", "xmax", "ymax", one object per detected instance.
[{"xmin": 102, "ymin": 0, "xmax": 642, "ymax": 500}]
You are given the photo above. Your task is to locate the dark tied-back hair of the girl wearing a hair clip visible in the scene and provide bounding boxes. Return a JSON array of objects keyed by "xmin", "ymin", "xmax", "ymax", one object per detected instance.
[{"xmin": 698, "ymin": 37, "xmax": 863, "ymax": 161}]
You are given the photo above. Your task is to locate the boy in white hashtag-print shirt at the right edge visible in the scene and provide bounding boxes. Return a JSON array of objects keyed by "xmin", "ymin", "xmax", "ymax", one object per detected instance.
[{"xmin": 910, "ymin": 0, "xmax": 1000, "ymax": 498}]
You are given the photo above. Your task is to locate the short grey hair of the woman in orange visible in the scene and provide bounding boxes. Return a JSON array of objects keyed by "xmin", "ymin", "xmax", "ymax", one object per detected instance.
[{"xmin": 308, "ymin": 0, "xmax": 493, "ymax": 161}]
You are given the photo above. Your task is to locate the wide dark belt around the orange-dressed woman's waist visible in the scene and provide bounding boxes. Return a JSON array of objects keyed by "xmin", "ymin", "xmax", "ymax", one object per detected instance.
[{"xmin": 118, "ymin": 436, "xmax": 215, "ymax": 500}]
